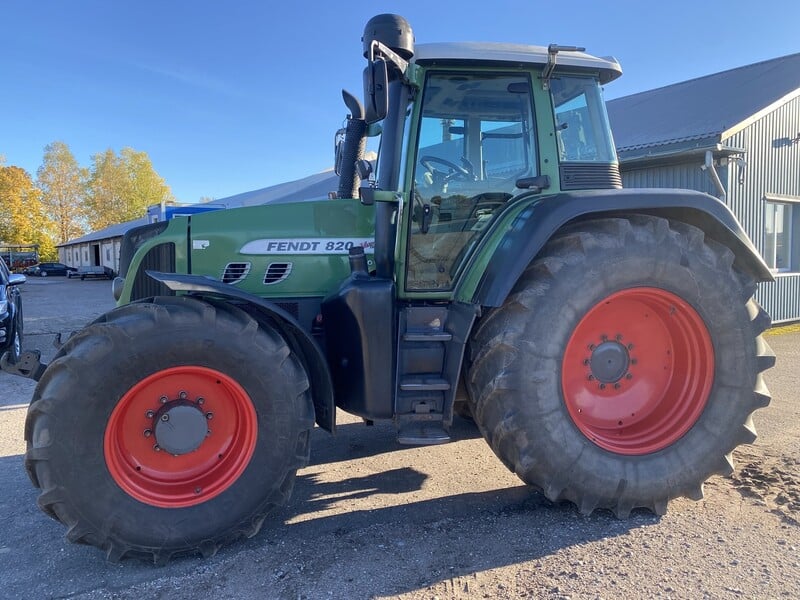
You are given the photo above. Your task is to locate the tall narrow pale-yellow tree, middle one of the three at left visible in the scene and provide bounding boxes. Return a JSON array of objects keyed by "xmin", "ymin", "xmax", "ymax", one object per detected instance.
[{"xmin": 36, "ymin": 142, "xmax": 86, "ymax": 243}]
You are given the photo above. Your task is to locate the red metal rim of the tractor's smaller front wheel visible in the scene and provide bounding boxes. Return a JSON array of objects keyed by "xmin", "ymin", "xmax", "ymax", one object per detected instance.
[{"xmin": 103, "ymin": 366, "xmax": 258, "ymax": 508}]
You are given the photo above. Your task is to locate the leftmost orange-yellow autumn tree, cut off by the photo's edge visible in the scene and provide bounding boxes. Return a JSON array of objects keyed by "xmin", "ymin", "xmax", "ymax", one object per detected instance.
[{"xmin": 0, "ymin": 165, "xmax": 56, "ymax": 259}]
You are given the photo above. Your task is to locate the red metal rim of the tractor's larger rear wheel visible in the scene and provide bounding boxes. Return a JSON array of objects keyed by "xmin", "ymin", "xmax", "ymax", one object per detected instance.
[{"xmin": 561, "ymin": 287, "xmax": 714, "ymax": 455}]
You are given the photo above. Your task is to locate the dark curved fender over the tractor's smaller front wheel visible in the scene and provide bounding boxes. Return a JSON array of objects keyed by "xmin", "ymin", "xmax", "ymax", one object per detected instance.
[{"xmin": 146, "ymin": 271, "xmax": 336, "ymax": 433}]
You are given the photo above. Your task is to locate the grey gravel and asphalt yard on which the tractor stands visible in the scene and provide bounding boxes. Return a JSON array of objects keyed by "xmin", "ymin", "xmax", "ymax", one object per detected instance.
[{"xmin": 0, "ymin": 278, "xmax": 800, "ymax": 600}]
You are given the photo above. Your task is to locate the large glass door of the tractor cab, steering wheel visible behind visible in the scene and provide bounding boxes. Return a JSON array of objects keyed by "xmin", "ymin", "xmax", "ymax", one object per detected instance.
[{"xmin": 398, "ymin": 70, "xmax": 539, "ymax": 298}]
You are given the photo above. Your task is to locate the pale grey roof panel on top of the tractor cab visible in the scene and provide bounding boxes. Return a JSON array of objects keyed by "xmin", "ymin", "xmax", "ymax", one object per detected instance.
[{"xmin": 411, "ymin": 42, "xmax": 622, "ymax": 83}]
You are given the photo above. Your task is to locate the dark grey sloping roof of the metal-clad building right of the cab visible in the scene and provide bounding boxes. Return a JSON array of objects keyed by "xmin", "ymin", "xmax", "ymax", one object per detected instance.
[{"xmin": 606, "ymin": 53, "xmax": 800, "ymax": 161}]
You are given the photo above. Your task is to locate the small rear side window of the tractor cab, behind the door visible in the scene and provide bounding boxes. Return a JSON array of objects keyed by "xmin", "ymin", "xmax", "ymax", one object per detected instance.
[{"xmin": 550, "ymin": 76, "xmax": 617, "ymax": 163}]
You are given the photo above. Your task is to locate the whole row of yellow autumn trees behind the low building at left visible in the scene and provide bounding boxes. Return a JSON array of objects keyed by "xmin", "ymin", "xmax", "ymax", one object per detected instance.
[{"xmin": 0, "ymin": 142, "xmax": 174, "ymax": 260}]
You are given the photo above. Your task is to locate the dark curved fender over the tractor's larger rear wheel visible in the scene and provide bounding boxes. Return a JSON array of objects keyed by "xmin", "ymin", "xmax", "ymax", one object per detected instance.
[{"xmin": 465, "ymin": 188, "xmax": 773, "ymax": 306}]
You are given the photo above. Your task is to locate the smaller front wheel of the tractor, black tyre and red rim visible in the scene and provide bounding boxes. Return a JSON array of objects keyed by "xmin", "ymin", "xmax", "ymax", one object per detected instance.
[{"xmin": 25, "ymin": 298, "xmax": 314, "ymax": 564}]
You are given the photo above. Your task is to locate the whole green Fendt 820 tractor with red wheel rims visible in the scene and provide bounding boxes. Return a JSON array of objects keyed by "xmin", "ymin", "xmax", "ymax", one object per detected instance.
[{"xmin": 15, "ymin": 15, "xmax": 774, "ymax": 563}]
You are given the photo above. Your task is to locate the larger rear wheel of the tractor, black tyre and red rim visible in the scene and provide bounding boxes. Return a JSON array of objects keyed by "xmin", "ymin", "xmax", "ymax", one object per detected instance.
[{"xmin": 467, "ymin": 216, "xmax": 774, "ymax": 517}]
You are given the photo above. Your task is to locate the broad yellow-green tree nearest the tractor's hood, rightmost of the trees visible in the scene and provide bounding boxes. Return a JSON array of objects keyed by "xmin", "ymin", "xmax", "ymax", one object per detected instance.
[{"xmin": 86, "ymin": 148, "xmax": 174, "ymax": 231}]
